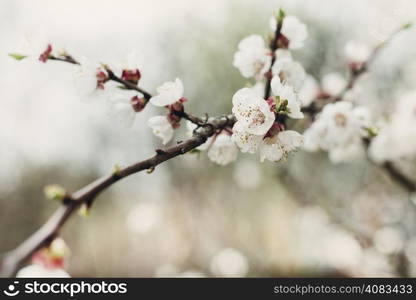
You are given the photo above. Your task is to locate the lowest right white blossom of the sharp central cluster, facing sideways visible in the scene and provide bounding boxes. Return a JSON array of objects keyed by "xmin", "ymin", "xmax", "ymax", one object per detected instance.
[{"xmin": 259, "ymin": 130, "xmax": 303, "ymax": 162}]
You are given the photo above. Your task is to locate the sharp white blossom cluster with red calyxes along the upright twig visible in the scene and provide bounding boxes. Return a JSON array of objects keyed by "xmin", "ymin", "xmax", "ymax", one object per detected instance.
[{"xmin": 232, "ymin": 16, "xmax": 310, "ymax": 162}]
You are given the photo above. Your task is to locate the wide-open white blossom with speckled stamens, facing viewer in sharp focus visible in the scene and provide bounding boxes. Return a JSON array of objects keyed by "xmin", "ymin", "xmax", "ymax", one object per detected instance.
[{"xmin": 232, "ymin": 88, "xmax": 275, "ymax": 135}]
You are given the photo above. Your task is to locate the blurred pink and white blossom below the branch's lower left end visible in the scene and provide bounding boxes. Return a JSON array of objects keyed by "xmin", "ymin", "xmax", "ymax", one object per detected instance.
[{"xmin": 16, "ymin": 238, "xmax": 71, "ymax": 278}]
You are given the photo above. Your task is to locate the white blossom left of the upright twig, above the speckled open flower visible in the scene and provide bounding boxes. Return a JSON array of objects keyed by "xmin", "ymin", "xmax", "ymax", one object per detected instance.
[{"xmin": 233, "ymin": 35, "xmax": 272, "ymax": 79}]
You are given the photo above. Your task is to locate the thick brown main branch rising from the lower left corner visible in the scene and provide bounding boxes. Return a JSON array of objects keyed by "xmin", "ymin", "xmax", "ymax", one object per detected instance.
[{"xmin": 0, "ymin": 115, "xmax": 235, "ymax": 277}]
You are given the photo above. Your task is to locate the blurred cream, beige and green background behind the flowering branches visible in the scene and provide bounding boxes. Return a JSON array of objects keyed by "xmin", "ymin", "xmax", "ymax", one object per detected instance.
[{"xmin": 0, "ymin": 0, "xmax": 416, "ymax": 277}]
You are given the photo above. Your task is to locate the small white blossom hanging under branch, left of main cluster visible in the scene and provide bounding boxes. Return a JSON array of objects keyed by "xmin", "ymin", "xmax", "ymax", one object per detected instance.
[{"xmin": 208, "ymin": 133, "xmax": 238, "ymax": 166}]
